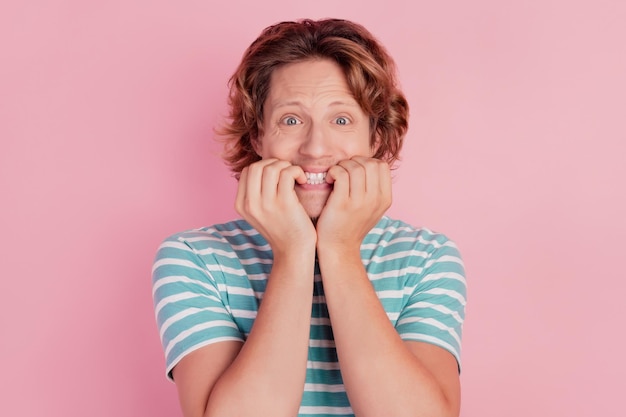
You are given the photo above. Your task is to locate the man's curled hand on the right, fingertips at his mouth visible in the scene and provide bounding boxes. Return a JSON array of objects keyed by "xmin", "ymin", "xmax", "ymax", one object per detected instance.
[{"xmin": 317, "ymin": 156, "xmax": 391, "ymax": 252}]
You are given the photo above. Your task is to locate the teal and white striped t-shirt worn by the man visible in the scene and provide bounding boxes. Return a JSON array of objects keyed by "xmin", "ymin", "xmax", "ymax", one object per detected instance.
[{"xmin": 152, "ymin": 217, "xmax": 466, "ymax": 417}]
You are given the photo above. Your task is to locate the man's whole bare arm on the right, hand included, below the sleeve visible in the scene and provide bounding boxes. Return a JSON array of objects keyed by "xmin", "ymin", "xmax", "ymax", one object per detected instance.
[{"xmin": 317, "ymin": 157, "xmax": 460, "ymax": 417}]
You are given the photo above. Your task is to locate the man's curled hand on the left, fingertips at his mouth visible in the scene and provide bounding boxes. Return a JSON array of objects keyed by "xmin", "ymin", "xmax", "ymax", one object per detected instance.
[{"xmin": 235, "ymin": 159, "xmax": 317, "ymax": 254}]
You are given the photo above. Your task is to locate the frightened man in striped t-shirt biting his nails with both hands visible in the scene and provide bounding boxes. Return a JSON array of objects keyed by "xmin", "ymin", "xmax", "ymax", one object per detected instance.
[{"xmin": 153, "ymin": 19, "xmax": 465, "ymax": 417}]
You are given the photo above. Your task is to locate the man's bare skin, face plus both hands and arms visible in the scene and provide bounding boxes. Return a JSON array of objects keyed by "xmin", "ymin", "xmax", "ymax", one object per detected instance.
[{"xmin": 173, "ymin": 60, "xmax": 460, "ymax": 417}]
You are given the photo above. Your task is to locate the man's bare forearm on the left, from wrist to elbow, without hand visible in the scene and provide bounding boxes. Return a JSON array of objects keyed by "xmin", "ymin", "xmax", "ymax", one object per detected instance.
[{"xmin": 205, "ymin": 252, "xmax": 314, "ymax": 417}]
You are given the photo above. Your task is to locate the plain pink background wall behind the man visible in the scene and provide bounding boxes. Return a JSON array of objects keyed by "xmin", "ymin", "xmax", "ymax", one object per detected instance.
[{"xmin": 0, "ymin": 0, "xmax": 626, "ymax": 417}]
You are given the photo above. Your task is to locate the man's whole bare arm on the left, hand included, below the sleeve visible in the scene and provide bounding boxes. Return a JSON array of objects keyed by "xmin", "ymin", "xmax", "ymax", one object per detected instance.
[{"xmin": 173, "ymin": 160, "xmax": 316, "ymax": 417}]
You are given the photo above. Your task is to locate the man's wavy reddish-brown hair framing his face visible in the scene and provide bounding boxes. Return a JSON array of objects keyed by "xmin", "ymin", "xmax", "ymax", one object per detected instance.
[{"xmin": 219, "ymin": 19, "xmax": 409, "ymax": 176}]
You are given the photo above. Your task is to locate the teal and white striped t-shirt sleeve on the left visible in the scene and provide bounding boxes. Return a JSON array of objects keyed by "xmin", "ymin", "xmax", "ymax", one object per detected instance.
[{"xmin": 152, "ymin": 236, "xmax": 244, "ymax": 379}]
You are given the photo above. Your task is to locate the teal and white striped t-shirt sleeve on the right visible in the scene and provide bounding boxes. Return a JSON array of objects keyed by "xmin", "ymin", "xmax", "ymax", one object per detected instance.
[{"xmin": 396, "ymin": 239, "xmax": 466, "ymax": 370}]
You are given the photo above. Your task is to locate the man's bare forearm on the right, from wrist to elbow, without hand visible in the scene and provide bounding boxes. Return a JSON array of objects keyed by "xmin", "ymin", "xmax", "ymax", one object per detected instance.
[{"xmin": 319, "ymin": 250, "xmax": 458, "ymax": 417}]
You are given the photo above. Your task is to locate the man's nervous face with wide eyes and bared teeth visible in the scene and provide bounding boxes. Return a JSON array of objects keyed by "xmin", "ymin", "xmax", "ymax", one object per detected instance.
[{"xmin": 256, "ymin": 60, "xmax": 374, "ymax": 218}]
